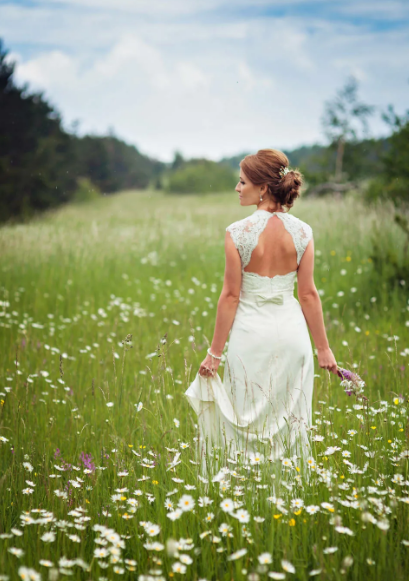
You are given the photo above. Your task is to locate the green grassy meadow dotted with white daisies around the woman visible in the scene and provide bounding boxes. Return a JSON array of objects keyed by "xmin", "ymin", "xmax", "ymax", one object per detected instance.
[{"xmin": 0, "ymin": 192, "xmax": 409, "ymax": 581}]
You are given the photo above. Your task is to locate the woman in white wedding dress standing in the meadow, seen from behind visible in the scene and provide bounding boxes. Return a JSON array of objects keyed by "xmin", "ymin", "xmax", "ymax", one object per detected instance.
[{"xmin": 185, "ymin": 149, "xmax": 337, "ymax": 472}]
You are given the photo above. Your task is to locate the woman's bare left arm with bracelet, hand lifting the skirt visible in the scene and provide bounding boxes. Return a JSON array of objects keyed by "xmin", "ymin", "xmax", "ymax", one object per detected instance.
[{"xmin": 199, "ymin": 232, "xmax": 242, "ymax": 375}]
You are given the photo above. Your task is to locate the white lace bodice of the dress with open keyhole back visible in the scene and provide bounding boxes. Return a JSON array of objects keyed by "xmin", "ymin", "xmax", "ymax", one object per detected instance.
[{"xmin": 226, "ymin": 210, "xmax": 312, "ymax": 292}]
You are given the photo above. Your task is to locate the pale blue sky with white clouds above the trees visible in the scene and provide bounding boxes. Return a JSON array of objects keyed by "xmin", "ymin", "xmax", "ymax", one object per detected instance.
[{"xmin": 0, "ymin": 0, "xmax": 409, "ymax": 161}]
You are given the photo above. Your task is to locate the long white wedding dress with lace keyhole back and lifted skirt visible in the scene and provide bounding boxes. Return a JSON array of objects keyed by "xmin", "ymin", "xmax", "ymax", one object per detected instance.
[{"xmin": 185, "ymin": 210, "xmax": 314, "ymax": 473}]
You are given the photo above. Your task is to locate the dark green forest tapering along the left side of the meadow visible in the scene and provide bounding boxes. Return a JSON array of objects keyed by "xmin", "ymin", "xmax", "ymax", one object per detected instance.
[{"xmin": 0, "ymin": 40, "xmax": 165, "ymax": 222}]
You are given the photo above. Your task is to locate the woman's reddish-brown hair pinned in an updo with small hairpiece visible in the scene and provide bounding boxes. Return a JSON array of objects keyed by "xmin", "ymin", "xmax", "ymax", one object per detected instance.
[{"xmin": 240, "ymin": 149, "xmax": 302, "ymax": 209}]
